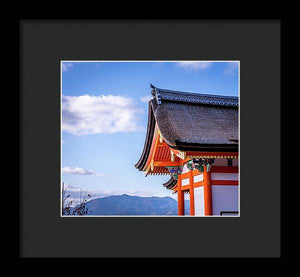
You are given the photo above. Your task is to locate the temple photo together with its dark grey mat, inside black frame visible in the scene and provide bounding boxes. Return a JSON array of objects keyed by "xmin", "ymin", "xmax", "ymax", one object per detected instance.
[{"xmin": 20, "ymin": 20, "xmax": 281, "ymax": 258}]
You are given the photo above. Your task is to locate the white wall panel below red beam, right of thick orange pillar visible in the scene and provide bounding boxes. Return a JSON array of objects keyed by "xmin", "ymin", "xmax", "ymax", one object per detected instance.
[{"xmin": 212, "ymin": 185, "xmax": 239, "ymax": 215}]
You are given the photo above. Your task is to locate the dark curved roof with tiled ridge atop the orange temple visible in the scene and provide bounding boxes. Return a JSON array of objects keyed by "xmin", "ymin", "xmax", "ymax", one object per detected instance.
[{"xmin": 135, "ymin": 84, "xmax": 239, "ymax": 174}]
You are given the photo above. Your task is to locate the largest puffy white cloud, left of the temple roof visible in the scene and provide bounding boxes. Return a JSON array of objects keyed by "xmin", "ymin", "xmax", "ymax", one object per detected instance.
[{"xmin": 62, "ymin": 95, "xmax": 143, "ymax": 136}]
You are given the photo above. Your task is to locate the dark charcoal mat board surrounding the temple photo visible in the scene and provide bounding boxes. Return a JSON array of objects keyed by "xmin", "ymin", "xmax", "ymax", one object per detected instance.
[{"xmin": 19, "ymin": 19, "xmax": 282, "ymax": 258}]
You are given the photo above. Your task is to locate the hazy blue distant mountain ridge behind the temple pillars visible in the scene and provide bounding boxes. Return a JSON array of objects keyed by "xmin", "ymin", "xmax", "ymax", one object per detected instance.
[{"xmin": 81, "ymin": 194, "xmax": 189, "ymax": 215}]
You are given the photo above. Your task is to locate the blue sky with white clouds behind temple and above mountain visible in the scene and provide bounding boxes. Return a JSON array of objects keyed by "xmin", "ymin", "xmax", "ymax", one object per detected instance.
[{"xmin": 61, "ymin": 61, "xmax": 239, "ymax": 198}]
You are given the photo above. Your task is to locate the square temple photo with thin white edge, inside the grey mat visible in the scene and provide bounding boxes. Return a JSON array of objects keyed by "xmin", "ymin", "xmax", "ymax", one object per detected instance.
[{"xmin": 61, "ymin": 60, "xmax": 240, "ymax": 217}]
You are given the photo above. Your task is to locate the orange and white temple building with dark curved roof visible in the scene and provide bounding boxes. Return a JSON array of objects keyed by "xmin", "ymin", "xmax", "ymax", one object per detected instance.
[{"xmin": 135, "ymin": 85, "xmax": 239, "ymax": 216}]
